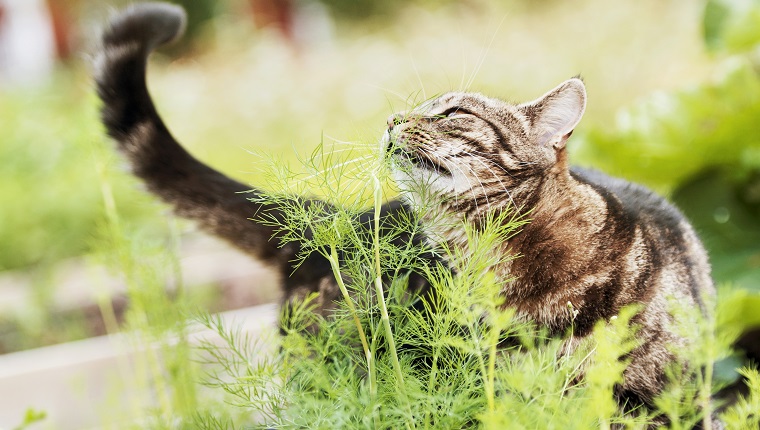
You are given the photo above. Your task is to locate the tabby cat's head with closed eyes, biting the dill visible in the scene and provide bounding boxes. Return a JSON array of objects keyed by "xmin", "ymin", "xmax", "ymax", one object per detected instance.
[{"xmin": 385, "ymin": 78, "xmax": 586, "ymax": 213}]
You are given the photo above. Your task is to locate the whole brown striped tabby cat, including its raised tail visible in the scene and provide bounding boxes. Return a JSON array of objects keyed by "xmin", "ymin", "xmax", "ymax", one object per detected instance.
[{"xmin": 94, "ymin": 3, "xmax": 715, "ymax": 422}]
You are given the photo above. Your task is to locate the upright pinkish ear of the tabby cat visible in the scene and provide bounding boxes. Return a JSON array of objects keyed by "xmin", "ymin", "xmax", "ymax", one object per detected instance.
[{"xmin": 518, "ymin": 78, "xmax": 586, "ymax": 148}]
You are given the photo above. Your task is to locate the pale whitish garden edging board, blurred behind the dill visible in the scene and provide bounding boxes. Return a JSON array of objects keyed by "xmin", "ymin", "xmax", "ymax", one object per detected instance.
[{"xmin": 0, "ymin": 304, "xmax": 278, "ymax": 430}]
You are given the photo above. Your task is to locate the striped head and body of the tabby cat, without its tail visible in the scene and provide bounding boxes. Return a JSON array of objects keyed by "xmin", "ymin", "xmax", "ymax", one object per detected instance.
[{"xmin": 385, "ymin": 79, "xmax": 714, "ymax": 410}]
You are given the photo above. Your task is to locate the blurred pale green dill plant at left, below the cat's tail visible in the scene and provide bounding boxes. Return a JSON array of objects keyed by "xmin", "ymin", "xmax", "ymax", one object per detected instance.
[{"xmin": 91, "ymin": 146, "xmax": 199, "ymax": 429}]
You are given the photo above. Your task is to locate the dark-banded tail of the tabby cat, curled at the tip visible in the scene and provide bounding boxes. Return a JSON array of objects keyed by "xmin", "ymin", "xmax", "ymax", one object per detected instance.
[{"xmin": 94, "ymin": 3, "xmax": 292, "ymax": 261}]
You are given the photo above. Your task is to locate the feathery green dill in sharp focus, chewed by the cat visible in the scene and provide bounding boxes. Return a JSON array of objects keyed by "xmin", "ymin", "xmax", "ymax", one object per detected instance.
[{"xmin": 191, "ymin": 134, "xmax": 760, "ymax": 429}]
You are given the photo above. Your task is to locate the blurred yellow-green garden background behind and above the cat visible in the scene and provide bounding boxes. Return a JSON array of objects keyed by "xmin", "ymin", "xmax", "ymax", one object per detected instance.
[{"xmin": 0, "ymin": 0, "xmax": 760, "ymax": 349}]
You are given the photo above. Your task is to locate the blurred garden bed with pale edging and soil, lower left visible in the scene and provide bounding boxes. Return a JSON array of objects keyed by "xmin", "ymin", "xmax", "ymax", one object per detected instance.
[{"xmin": 0, "ymin": 233, "xmax": 279, "ymax": 429}]
